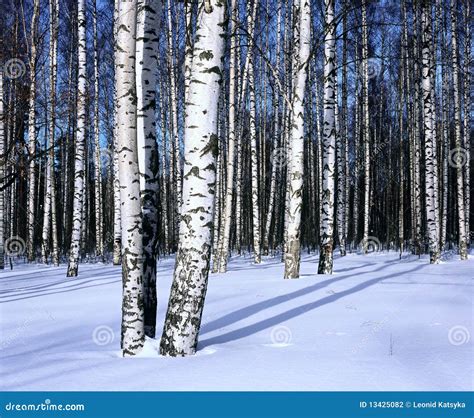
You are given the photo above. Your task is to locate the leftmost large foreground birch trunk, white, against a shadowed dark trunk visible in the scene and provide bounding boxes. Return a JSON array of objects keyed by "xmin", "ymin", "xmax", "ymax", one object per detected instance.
[{"xmin": 116, "ymin": 0, "xmax": 145, "ymax": 357}]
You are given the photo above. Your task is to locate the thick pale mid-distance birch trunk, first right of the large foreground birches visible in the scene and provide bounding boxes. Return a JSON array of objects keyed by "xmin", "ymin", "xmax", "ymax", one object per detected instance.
[{"xmin": 285, "ymin": 0, "xmax": 311, "ymax": 279}]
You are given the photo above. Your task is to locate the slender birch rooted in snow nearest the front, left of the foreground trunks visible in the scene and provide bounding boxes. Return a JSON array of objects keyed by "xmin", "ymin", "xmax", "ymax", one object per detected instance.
[{"xmin": 67, "ymin": 0, "xmax": 87, "ymax": 277}]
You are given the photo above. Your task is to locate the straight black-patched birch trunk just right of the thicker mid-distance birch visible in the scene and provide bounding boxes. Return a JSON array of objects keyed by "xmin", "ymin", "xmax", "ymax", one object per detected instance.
[{"xmin": 318, "ymin": 0, "xmax": 337, "ymax": 274}]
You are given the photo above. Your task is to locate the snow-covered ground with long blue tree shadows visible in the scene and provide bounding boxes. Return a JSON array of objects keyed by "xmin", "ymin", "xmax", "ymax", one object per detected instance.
[{"xmin": 0, "ymin": 253, "xmax": 474, "ymax": 390}]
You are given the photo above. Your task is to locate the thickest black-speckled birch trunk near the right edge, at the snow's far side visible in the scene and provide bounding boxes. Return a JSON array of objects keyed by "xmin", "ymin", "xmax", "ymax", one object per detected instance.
[{"xmin": 421, "ymin": 0, "xmax": 440, "ymax": 264}]
